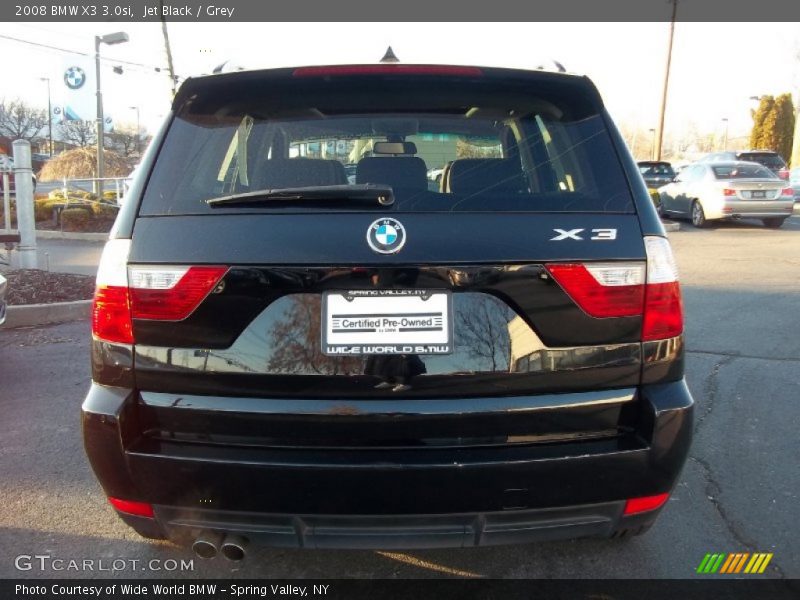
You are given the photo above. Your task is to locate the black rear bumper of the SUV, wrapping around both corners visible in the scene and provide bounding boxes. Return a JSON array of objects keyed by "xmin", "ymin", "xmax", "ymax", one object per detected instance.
[{"xmin": 83, "ymin": 381, "xmax": 693, "ymax": 548}]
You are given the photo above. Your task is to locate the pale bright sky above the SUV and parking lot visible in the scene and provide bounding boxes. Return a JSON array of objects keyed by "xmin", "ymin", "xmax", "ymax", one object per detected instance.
[{"xmin": 0, "ymin": 22, "xmax": 800, "ymax": 146}]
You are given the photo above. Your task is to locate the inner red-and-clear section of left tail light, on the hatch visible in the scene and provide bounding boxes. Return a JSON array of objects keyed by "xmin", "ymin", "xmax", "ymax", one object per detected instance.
[{"xmin": 128, "ymin": 265, "xmax": 228, "ymax": 321}]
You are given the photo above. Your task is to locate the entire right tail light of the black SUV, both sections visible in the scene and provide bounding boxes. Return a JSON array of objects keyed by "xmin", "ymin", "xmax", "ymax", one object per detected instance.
[{"xmin": 547, "ymin": 236, "xmax": 683, "ymax": 341}]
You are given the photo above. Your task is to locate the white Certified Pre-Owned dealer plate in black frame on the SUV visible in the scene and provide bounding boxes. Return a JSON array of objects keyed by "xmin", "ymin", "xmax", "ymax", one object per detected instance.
[{"xmin": 321, "ymin": 290, "xmax": 453, "ymax": 356}]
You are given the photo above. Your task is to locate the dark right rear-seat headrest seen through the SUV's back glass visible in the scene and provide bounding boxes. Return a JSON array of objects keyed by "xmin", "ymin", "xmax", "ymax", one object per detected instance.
[{"xmin": 448, "ymin": 158, "xmax": 523, "ymax": 194}]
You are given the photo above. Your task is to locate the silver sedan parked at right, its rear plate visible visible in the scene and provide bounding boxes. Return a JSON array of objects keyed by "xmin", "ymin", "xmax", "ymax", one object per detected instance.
[{"xmin": 658, "ymin": 161, "xmax": 794, "ymax": 229}]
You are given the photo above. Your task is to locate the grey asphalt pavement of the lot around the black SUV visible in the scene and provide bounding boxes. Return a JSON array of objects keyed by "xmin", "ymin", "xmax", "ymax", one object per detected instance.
[{"xmin": 0, "ymin": 217, "xmax": 800, "ymax": 578}]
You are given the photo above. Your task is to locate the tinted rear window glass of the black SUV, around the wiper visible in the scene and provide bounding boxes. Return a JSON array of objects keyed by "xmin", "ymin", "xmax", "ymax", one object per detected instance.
[{"xmin": 140, "ymin": 78, "xmax": 634, "ymax": 215}]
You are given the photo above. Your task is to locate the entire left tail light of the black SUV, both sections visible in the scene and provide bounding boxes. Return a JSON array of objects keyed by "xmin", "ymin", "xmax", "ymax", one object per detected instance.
[{"xmin": 92, "ymin": 240, "xmax": 228, "ymax": 344}]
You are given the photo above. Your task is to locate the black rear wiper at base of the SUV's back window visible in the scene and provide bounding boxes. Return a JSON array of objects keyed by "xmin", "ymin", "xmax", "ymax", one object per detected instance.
[{"xmin": 206, "ymin": 183, "xmax": 394, "ymax": 208}]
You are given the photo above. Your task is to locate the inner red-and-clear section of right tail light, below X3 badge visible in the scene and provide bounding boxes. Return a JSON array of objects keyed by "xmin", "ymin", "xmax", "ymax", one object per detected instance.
[{"xmin": 547, "ymin": 263, "xmax": 645, "ymax": 318}]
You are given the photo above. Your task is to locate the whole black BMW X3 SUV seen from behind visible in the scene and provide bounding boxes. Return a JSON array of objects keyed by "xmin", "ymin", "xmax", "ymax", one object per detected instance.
[{"xmin": 82, "ymin": 64, "xmax": 693, "ymax": 560}]
